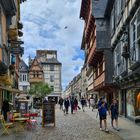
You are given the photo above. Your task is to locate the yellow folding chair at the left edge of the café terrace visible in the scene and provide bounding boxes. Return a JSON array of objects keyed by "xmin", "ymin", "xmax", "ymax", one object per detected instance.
[{"xmin": 0, "ymin": 115, "xmax": 13, "ymax": 134}]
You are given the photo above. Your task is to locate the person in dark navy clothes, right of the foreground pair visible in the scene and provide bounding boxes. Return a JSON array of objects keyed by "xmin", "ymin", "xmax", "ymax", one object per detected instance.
[{"xmin": 109, "ymin": 99, "xmax": 119, "ymax": 131}]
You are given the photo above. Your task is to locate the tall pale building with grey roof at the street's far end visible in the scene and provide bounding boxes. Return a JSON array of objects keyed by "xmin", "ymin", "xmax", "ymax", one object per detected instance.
[{"xmin": 36, "ymin": 50, "xmax": 62, "ymax": 101}]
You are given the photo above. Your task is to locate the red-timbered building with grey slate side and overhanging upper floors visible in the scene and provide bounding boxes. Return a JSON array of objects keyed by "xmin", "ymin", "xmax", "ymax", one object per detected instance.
[{"xmin": 80, "ymin": 0, "xmax": 115, "ymax": 104}]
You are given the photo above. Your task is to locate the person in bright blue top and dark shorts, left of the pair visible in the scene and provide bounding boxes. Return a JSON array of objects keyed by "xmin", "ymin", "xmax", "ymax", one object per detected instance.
[{"xmin": 98, "ymin": 98, "xmax": 108, "ymax": 132}]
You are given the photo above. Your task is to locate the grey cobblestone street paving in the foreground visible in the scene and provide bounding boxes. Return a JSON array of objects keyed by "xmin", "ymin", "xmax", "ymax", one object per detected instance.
[{"xmin": 0, "ymin": 108, "xmax": 121, "ymax": 140}]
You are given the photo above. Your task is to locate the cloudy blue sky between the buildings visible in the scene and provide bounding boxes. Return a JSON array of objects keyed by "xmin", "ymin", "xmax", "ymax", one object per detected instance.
[{"xmin": 21, "ymin": 0, "xmax": 84, "ymax": 89}]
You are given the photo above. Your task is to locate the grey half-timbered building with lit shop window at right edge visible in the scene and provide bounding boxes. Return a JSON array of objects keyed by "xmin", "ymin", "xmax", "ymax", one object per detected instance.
[{"xmin": 110, "ymin": 0, "xmax": 140, "ymax": 121}]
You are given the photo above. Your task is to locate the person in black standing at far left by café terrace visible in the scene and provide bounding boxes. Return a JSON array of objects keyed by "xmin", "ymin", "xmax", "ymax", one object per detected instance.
[{"xmin": 1, "ymin": 99, "xmax": 10, "ymax": 121}]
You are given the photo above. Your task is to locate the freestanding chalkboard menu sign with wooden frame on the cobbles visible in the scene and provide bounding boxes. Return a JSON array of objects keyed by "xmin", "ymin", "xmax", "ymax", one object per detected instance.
[{"xmin": 42, "ymin": 103, "xmax": 55, "ymax": 127}]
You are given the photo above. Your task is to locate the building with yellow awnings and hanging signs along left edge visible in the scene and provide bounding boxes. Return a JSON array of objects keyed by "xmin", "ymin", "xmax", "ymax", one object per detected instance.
[{"xmin": 0, "ymin": 0, "xmax": 24, "ymax": 109}]
